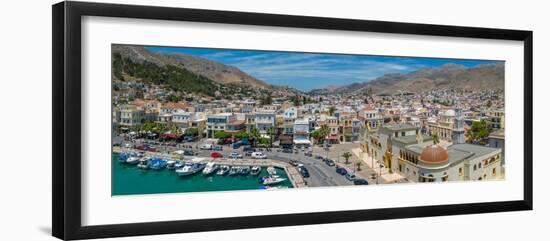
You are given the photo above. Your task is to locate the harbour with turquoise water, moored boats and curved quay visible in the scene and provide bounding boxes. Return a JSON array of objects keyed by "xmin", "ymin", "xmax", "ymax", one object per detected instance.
[{"xmin": 112, "ymin": 147, "xmax": 307, "ymax": 196}]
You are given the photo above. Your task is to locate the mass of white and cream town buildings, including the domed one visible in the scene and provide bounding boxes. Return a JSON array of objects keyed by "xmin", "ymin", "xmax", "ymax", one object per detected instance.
[{"xmin": 113, "ymin": 85, "xmax": 505, "ymax": 182}]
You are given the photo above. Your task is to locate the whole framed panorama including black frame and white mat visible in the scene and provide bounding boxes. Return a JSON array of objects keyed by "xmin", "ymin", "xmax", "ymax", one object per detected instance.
[{"xmin": 53, "ymin": 1, "xmax": 533, "ymax": 239}]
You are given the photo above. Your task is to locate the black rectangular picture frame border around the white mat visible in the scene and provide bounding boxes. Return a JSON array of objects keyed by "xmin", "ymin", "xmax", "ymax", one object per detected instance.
[{"xmin": 52, "ymin": 2, "xmax": 533, "ymax": 239}]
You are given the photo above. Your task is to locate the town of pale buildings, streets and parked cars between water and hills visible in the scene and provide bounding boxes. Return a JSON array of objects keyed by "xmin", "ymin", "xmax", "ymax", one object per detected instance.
[{"xmin": 113, "ymin": 78, "xmax": 505, "ymax": 191}]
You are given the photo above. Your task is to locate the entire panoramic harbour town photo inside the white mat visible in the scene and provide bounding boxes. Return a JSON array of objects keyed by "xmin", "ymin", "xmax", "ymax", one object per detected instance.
[{"xmin": 111, "ymin": 45, "xmax": 505, "ymax": 195}]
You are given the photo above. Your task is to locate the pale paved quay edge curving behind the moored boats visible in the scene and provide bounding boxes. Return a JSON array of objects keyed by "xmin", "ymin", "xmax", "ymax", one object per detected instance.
[{"xmin": 112, "ymin": 147, "xmax": 307, "ymax": 188}]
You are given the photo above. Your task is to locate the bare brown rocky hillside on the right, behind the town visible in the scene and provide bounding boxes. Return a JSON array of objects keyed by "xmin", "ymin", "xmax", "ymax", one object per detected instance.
[{"xmin": 310, "ymin": 63, "xmax": 504, "ymax": 94}]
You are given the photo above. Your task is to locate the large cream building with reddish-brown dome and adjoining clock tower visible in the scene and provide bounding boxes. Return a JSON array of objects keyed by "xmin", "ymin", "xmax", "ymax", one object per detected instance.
[{"xmin": 362, "ymin": 110, "xmax": 503, "ymax": 182}]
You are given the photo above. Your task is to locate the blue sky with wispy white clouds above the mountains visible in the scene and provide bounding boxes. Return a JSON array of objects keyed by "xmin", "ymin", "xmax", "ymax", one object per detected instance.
[{"xmin": 146, "ymin": 47, "xmax": 496, "ymax": 91}]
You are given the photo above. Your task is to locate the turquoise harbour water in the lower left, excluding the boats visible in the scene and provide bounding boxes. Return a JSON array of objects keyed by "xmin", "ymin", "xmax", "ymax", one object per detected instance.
[{"xmin": 111, "ymin": 153, "xmax": 292, "ymax": 196}]
